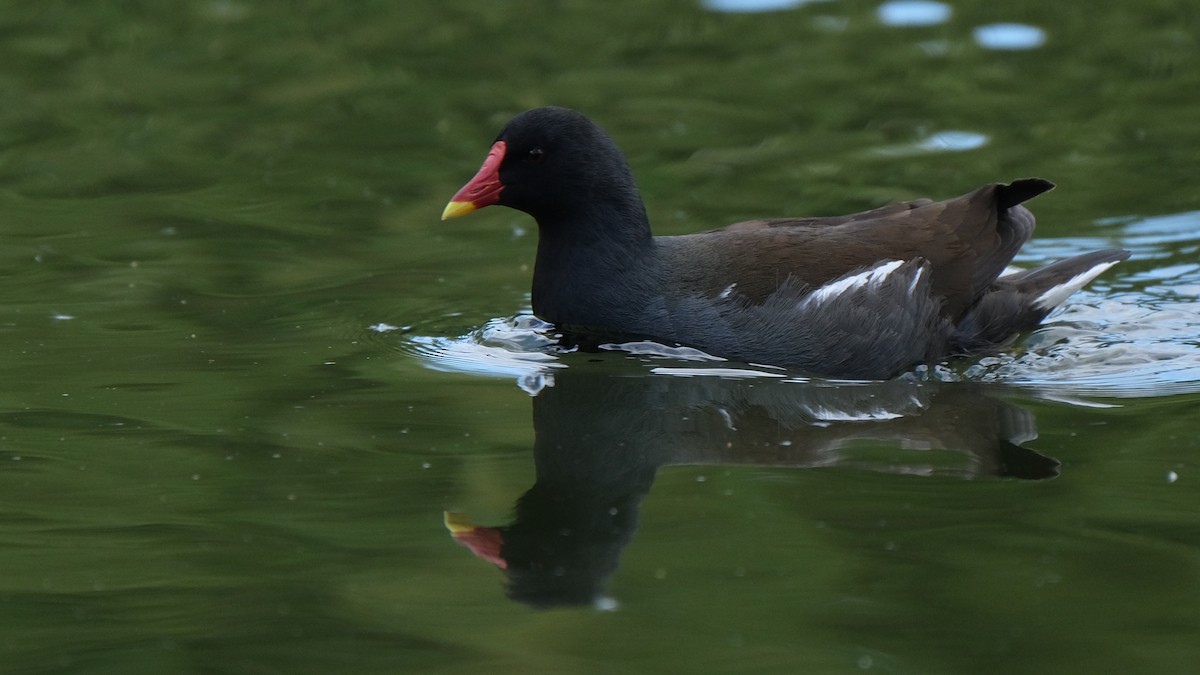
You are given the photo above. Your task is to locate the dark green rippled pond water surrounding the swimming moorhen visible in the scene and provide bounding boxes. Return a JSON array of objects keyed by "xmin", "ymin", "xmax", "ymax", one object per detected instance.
[{"xmin": 0, "ymin": 0, "xmax": 1200, "ymax": 674}]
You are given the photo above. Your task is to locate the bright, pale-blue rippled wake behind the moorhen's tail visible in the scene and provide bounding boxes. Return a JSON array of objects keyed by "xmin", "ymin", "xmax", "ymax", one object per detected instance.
[{"xmin": 919, "ymin": 211, "xmax": 1200, "ymax": 398}]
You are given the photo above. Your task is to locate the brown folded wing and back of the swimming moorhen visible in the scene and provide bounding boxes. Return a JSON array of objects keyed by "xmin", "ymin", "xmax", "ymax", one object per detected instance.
[{"xmin": 662, "ymin": 179, "xmax": 1054, "ymax": 317}]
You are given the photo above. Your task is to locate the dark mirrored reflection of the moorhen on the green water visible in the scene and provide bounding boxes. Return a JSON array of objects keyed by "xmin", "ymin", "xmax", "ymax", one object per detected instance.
[{"xmin": 446, "ymin": 368, "xmax": 1058, "ymax": 608}]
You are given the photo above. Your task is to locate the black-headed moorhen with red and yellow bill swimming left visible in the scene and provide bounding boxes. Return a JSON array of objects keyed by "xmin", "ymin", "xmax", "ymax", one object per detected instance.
[{"xmin": 442, "ymin": 107, "xmax": 1129, "ymax": 380}]
